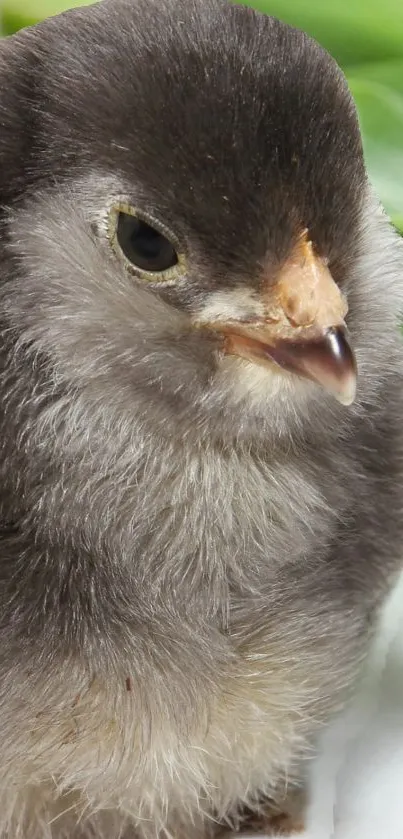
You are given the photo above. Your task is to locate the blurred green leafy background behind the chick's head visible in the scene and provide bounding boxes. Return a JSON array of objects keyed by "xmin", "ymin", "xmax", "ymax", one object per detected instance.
[{"xmin": 0, "ymin": 0, "xmax": 403, "ymax": 231}]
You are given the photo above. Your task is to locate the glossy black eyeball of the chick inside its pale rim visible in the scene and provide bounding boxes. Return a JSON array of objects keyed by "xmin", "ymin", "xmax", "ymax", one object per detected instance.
[{"xmin": 116, "ymin": 213, "xmax": 178, "ymax": 274}]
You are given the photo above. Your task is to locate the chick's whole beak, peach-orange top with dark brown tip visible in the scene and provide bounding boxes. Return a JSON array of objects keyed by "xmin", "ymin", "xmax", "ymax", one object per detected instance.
[{"xmin": 205, "ymin": 231, "xmax": 357, "ymax": 405}]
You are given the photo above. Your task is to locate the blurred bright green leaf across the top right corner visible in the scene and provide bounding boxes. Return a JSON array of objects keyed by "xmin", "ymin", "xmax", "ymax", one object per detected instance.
[{"xmin": 235, "ymin": 0, "xmax": 403, "ymax": 64}]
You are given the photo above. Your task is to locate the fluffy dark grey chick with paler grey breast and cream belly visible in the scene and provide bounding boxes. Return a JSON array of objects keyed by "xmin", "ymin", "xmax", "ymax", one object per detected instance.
[{"xmin": 0, "ymin": 0, "xmax": 403, "ymax": 839}]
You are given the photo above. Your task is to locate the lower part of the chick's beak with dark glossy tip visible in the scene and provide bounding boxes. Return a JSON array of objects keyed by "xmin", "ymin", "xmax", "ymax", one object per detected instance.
[{"xmin": 225, "ymin": 326, "xmax": 357, "ymax": 405}]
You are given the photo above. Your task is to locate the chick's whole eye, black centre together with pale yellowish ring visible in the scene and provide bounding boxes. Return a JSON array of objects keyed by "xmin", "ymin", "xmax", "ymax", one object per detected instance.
[{"xmin": 107, "ymin": 201, "xmax": 186, "ymax": 283}]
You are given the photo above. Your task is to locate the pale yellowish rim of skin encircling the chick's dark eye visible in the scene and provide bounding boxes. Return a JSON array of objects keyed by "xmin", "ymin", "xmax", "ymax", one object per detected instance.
[{"xmin": 107, "ymin": 199, "xmax": 187, "ymax": 284}]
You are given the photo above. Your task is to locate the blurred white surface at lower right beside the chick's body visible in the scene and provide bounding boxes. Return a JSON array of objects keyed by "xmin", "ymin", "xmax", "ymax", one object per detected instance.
[{"xmin": 243, "ymin": 577, "xmax": 403, "ymax": 839}]
